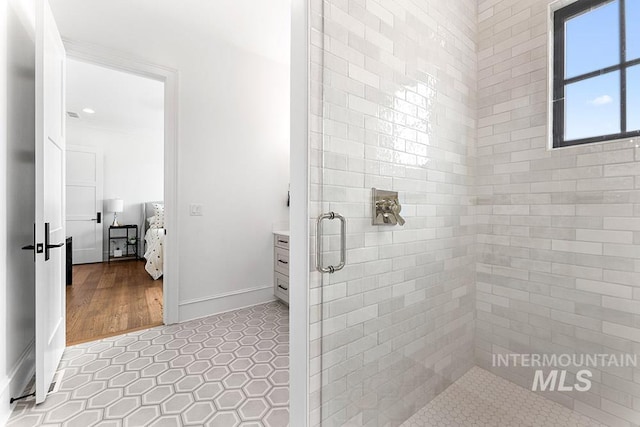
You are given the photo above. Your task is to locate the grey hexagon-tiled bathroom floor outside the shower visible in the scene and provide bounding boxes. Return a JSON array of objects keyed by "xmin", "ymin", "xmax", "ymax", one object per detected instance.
[{"xmin": 8, "ymin": 302, "xmax": 289, "ymax": 427}]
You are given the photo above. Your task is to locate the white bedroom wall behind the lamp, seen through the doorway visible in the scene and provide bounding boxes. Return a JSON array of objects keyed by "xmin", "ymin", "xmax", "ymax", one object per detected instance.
[{"xmin": 67, "ymin": 122, "xmax": 164, "ymax": 259}]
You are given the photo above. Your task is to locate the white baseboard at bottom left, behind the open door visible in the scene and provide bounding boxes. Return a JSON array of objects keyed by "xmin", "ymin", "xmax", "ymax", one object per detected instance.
[{"xmin": 0, "ymin": 341, "xmax": 36, "ymax": 425}]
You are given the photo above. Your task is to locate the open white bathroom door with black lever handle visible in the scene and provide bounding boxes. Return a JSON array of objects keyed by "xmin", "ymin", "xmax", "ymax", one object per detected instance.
[{"xmin": 35, "ymin": 0, "xmax": 65, "ymax": 403}]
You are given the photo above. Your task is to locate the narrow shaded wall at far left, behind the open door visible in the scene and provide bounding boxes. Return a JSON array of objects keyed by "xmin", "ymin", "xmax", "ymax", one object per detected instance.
[{"xmin": 0, "ymin": 0, "xmax": 35, "ymax": 423}]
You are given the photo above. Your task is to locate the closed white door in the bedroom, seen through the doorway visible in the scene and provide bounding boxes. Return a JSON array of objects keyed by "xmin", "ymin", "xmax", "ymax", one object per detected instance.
[{"xmin": 66, "ymin": 145, "xmax": 104, "ymax": 264}]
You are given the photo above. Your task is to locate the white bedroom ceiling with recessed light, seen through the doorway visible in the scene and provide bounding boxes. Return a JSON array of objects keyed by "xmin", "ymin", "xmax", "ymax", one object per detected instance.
[{"xmin": 66, "ymin": 59, "xmax": 164, "ymax": 132}]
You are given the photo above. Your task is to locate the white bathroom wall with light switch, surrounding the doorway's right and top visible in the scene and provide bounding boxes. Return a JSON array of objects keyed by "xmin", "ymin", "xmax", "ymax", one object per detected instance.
[{"xmin": 51, "ymin": 0, "xmax": 289, "ymax": 320}]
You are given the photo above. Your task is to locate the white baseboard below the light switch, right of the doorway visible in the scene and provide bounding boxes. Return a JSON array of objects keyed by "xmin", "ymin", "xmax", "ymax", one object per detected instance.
[{"xmin": 178, "ymin": 285, "xmax": 275, "ymax": 322}]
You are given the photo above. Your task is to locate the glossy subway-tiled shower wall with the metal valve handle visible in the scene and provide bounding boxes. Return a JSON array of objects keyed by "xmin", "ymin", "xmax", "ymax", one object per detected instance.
[{"xmin": 310, "ymin": 0, "xmax": 478, "ymax": 426}]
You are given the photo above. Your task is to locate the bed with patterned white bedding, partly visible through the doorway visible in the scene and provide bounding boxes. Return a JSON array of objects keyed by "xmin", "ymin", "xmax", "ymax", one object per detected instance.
[{"xmin": 141, "ymin": 201, "xmax": 166, "ymax": 280}]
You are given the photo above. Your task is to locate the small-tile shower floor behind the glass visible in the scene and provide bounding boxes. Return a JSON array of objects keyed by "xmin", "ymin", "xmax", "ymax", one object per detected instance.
[{"xmin": 401, "ymin": 366, "xmax": 606, "ymax": 427}]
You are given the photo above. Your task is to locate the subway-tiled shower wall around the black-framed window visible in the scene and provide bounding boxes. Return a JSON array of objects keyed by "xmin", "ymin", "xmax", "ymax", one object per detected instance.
[{"xmin": 475, "ymin": 0, "xmax": 640, "ymax": 426}]
